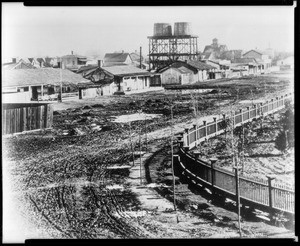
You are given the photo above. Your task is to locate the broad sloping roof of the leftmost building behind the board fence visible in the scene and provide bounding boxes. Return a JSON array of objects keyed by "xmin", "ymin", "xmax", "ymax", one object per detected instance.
[{"xmin": 2, "ymin": 68, "xmax": 89, "ymax": 87}]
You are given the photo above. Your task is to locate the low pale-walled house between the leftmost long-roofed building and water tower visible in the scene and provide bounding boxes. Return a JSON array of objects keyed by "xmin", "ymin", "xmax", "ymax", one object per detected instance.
[{"xmin": 77, "ymin": 65, "xmax": 152, "ymax": 95}]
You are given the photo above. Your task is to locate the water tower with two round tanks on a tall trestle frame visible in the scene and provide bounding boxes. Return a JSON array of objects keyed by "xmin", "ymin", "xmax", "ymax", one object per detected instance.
[{"xmin": 148, "ymin": 22, "xmax": 199, "ymax": 69}]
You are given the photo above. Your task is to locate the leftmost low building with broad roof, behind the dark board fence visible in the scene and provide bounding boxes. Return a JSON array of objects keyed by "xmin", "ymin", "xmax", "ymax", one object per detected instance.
[{"xmin": 2, "ymin": 68, "xmax": 90, "ymax": 102}]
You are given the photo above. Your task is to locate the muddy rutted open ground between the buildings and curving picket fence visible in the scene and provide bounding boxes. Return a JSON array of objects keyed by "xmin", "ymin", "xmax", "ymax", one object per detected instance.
[{"xmin": 3, "ymin": 72, "xmax": 293, "ymax": 239}]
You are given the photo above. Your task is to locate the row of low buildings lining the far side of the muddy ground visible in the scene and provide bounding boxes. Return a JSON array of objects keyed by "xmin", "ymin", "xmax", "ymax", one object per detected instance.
[{"xmin": 2, "ymin": 36, "xmax": 293, "ymax": 102}]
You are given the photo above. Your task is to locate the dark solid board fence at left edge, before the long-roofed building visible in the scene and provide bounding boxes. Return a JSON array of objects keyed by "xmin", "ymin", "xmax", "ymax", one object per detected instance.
[{"xmin": 2, "ymin": 103, "xmax": 53, "ymax": 135}]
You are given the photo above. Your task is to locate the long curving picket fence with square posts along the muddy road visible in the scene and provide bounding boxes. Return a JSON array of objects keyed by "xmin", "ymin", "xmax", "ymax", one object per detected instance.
[{"xmin": 174, "ymin": 93, "xmax": 295, "ymax": 216}]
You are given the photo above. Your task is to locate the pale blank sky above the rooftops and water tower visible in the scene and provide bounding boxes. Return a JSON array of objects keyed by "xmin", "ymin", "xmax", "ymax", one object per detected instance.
[{"xmin": 2, "ymin": 3, "xmax": 294, "ymax": 59}]
